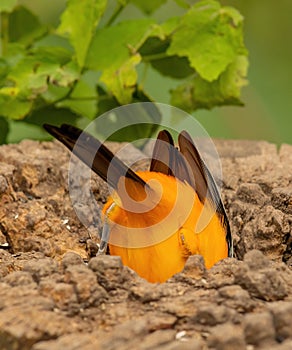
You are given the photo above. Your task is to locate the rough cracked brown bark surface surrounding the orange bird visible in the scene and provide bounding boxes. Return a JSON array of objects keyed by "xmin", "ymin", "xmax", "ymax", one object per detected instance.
[{"xmin": 0, "ymin": 141, "xmax": 292, "ymax": 350}]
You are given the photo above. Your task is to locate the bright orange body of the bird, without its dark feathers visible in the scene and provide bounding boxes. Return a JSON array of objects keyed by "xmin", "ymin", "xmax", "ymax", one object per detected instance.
[{"xmin": 104, "ymin": 171, "xmax": 228, "ymax": 282}]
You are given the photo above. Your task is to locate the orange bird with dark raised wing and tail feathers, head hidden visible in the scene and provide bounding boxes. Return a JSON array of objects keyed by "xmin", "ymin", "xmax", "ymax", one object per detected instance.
[{"xmin": 44, "ymin": 124, "xmax": 233, "ymax": 282}]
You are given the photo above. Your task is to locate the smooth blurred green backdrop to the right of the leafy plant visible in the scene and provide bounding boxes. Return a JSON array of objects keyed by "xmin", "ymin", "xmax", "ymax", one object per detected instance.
[{"xmin": 195, "ymin": 0, "xmax": 292, "ymax": 145}]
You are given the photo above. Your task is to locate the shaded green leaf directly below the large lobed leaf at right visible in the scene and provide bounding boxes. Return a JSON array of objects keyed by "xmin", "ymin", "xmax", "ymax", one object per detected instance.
[{"xmin": 171, "ymin": 56, "xmax": 248, "ymax": 112}]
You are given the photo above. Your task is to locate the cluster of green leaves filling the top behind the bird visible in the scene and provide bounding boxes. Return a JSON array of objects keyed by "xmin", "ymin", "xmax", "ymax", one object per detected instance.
[{"xmin": 0, "ymin": 0, "xmax": 248, "ymax": 142}]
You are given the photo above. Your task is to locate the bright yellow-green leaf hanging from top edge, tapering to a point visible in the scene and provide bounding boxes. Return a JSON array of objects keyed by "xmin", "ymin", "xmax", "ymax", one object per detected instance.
[{"xmin": 58, "ymin": 0, "xmax": 107, "ymax": 67}]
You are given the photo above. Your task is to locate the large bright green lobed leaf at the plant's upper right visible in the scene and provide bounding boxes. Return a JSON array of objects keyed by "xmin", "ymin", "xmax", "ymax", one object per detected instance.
[{"xmin": 167, "ymin": 0, "xmax": 246, "ymax": 82}]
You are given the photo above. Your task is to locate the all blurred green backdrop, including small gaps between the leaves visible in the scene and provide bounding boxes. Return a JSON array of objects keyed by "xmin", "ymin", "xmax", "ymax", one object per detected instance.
[{"xmin": 9, "ymin": 0, "xmax": 292, "ymax": 145}]
